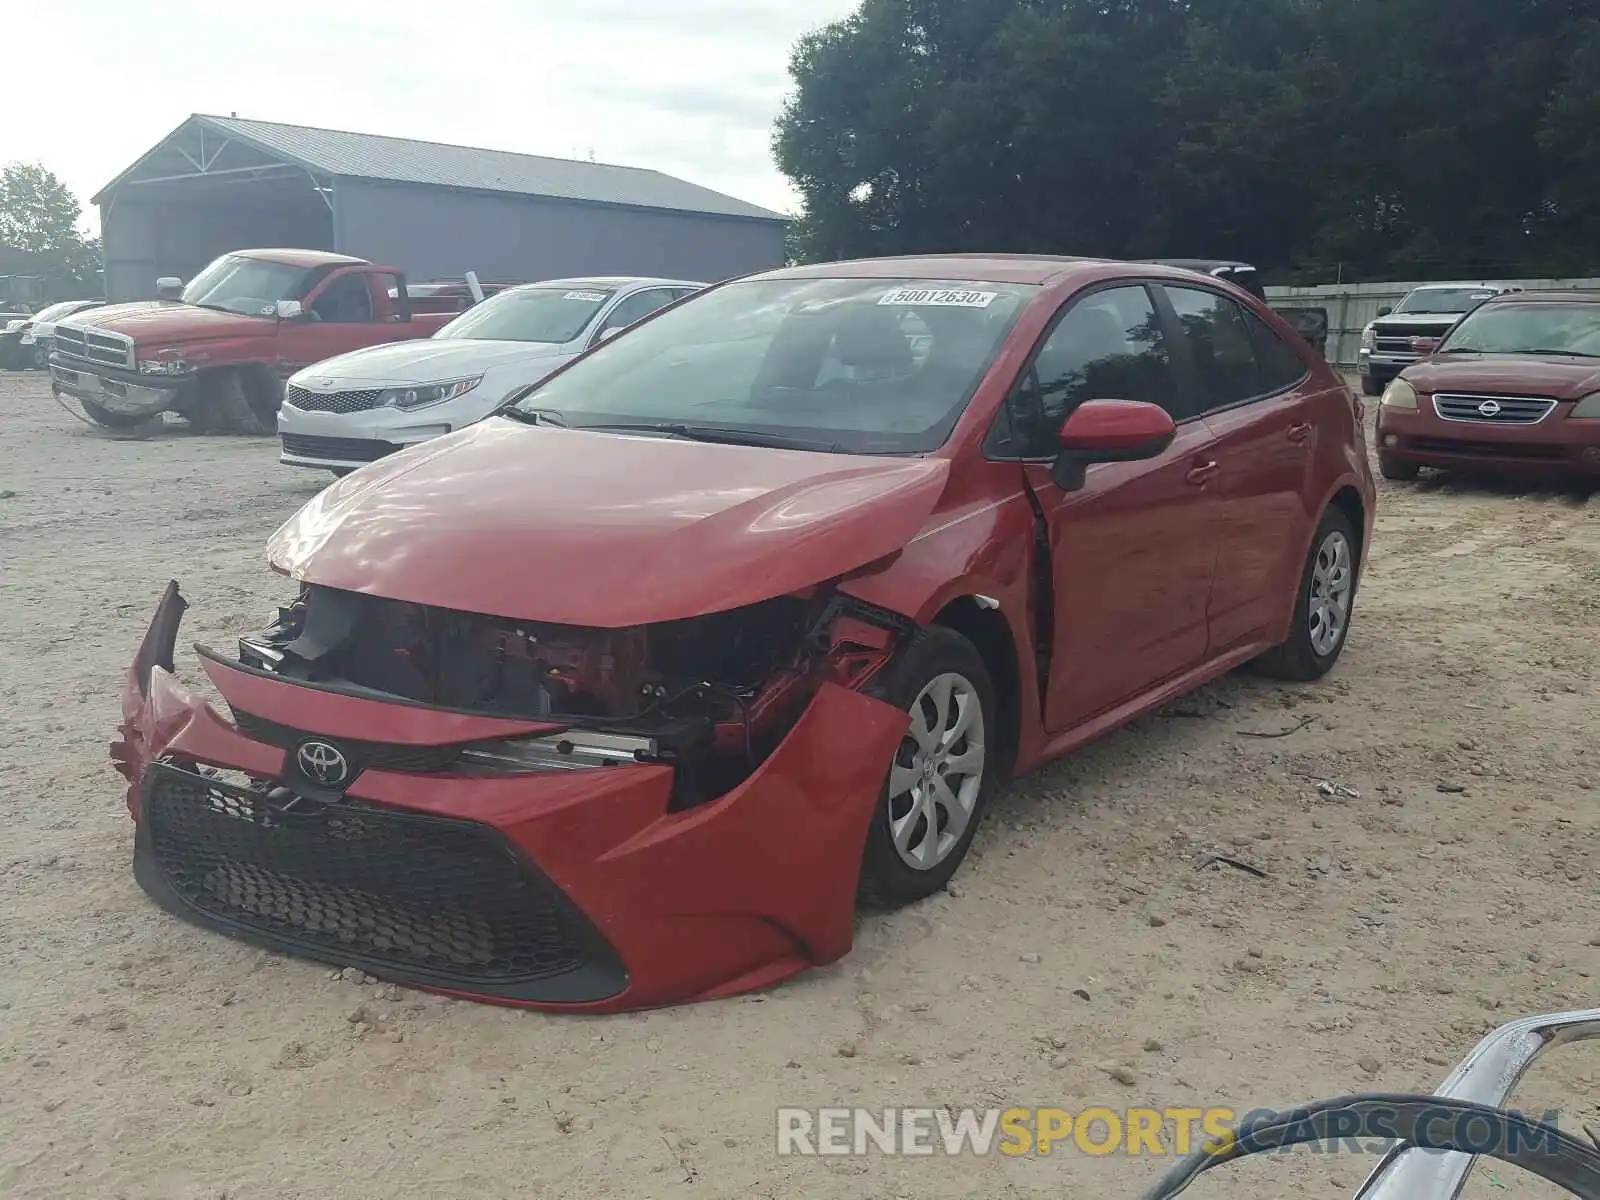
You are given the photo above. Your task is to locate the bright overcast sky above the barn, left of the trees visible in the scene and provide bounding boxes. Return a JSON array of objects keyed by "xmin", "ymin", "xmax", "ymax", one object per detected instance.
[{"xmin": 0, "ymin": 0, "xmax": 859, "ymax": 226}]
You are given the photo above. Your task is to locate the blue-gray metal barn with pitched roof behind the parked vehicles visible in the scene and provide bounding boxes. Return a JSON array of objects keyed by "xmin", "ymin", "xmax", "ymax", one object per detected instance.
[{"xmin": 93, "ymin": 115, "xmax": 787, "ymax": 301}]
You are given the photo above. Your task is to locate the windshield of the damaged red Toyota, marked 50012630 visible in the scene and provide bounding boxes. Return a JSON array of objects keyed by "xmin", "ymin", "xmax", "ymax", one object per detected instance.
[{"xmin": 515, "ymin": 278, "xmax": 1038, "ymax": 454}]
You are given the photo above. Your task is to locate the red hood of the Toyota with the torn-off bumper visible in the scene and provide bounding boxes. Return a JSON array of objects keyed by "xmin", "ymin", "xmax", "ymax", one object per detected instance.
[{"xmin": 267, "ymin": 419, "xmax": 949, "ymax": 629}]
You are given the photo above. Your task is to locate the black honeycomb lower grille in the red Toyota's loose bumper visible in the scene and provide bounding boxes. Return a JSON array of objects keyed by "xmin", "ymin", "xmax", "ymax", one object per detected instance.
[{"xmin": 142, "ymin": 763, "xmax": 626, "ymax": 998}]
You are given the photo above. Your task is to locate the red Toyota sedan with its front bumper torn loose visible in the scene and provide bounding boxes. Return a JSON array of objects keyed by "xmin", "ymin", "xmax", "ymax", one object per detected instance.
[{"xmin": 112, "ymin": 256, "xmax": 1373, "ymax": 1011}]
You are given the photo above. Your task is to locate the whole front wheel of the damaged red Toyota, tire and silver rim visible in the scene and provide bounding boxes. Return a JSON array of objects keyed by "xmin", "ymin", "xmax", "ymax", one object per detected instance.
[{"xmin": 859, "ymin": 626, "xmax": 1000, "ymax": 907}]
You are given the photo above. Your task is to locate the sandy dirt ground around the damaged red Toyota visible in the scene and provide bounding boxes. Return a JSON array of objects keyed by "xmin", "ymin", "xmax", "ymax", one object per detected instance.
[{"xmin": 0, "ymin": 374, "xmax": 1600, "ymax": 1200}]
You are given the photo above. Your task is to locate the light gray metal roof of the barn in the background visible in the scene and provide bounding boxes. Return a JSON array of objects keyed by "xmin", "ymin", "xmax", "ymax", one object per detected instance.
[{"xmin": 94, "ymin": 114, "xmax": 789, "ymax": 221}]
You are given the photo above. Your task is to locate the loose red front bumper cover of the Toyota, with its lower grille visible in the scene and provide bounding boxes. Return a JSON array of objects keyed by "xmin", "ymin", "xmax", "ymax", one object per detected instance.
[{"xmin": 112, "ymin": 584, "xmax": 907, "ymax": 1011}]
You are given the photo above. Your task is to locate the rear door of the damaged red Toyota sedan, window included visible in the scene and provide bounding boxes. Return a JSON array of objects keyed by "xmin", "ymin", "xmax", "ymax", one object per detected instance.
[{"xmin": 1162, "ymin": 285, "xmax": 1317, "ymax": 658}]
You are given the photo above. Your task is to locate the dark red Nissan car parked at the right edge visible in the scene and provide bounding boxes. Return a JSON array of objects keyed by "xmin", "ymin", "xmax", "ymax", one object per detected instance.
[{"xmin": 1378, "ymin": 291, "xmax": 1600, "ymax": 480}]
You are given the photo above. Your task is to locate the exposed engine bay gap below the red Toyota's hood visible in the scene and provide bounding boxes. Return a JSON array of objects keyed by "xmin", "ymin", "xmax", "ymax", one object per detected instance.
[{"xmin": 238, "ymin": 586, "xmax": 915, "ymax": 805}]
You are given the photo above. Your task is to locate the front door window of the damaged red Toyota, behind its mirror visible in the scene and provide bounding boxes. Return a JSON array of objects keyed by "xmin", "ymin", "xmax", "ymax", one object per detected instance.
[{"xmin": 990, "ymin": 286, "xmax": 1187, "ymax": 458}]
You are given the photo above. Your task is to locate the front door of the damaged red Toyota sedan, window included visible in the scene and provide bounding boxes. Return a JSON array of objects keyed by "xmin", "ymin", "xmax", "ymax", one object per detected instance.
[{"xmin": 1008, "ymin": 285, "xmax": 1219, "ymax": 731}]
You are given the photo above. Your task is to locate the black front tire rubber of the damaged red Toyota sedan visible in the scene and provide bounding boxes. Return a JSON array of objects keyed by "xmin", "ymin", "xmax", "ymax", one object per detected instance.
[{"xmin": 858, "ymin": 626, "xmax": 1000, "ymax": 909}]
